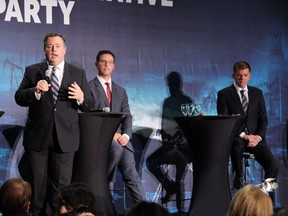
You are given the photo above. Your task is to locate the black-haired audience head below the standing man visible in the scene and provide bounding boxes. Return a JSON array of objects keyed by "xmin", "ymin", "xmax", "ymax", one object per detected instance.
[{"xmin": 58, "ymin": 183, "xmax": 103, "ymax": 216}]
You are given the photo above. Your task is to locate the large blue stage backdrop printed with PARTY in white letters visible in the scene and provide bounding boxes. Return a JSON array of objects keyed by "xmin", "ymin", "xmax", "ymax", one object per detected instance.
[{"xmin": 0, "ymin": 0, "xmax": 288, "ymax": 211}]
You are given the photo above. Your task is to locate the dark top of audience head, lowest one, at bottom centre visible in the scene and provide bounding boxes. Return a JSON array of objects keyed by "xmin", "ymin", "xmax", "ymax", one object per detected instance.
[{"xmin": 126, "ymin": 201, "xmax": 169, "ymax": 216}]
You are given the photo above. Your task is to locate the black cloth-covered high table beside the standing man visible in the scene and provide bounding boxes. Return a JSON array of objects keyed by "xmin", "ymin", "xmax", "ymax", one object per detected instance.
[{"xmin": 72, "ymin": 113, "xmax": 126, "ymax": 216}]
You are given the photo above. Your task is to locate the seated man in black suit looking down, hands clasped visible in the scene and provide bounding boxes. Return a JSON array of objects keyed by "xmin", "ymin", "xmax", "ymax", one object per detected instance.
[{"xmin": 217, "ymin": 61, "xmax": 278, "ymax": 189}]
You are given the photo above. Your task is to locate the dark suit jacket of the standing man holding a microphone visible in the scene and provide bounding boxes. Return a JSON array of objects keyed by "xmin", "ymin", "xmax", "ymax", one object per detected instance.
[{"xmin": 15, "ymin": 62, "xmax": 94, "ymax": 152}]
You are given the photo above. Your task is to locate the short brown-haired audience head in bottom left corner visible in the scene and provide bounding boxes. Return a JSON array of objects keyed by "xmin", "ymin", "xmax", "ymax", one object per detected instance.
[{"xmin": 0, "ymin": 178, "xmax": 32, "ymax": 216}]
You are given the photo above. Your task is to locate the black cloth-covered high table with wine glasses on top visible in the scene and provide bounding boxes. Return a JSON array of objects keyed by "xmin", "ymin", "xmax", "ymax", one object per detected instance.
[{"xmin": 175, "ymin": 116, "xmax": 245, "ymax": 216}]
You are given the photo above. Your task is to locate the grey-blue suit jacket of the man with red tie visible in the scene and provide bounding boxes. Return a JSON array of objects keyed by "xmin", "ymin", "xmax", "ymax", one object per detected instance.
[{"xmin": 89, "ymin": 77, "xmax": 134, "ymax": 151}]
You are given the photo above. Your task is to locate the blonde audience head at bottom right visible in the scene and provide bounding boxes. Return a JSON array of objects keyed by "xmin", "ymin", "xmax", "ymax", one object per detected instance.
[{"xmin": 227, "ymin": 184, "xmax": 273, "ymax": 216}]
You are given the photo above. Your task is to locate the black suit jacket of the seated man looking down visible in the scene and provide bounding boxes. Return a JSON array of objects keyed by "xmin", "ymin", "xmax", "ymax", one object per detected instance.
[{"xmin": 217, "ymin": 85, "xmax": 268, "ymax": 140}]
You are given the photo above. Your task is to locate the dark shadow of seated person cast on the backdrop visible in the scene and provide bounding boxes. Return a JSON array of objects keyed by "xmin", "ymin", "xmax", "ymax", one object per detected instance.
[{"xmin": 146, "ymin": 71, "xmax": 193, "ymax": 212}]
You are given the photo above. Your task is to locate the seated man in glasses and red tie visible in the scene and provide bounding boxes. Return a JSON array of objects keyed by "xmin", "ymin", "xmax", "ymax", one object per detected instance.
[{"xmin": 89, "ymin": 50, "xmax": 145, "ymax": 202}]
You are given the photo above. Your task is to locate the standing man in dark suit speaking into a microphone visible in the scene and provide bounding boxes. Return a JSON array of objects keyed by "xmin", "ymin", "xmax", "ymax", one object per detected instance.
[{"xmin": 15, "ymin": 33, "xmax": 94, "ymax": 215}]
